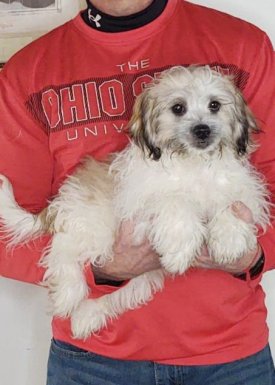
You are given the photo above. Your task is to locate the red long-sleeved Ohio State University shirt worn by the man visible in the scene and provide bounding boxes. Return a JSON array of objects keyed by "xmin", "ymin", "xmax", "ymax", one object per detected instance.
[{"xmin": 0, "ymin": 0, "xmax": 275, "ymax": 364}]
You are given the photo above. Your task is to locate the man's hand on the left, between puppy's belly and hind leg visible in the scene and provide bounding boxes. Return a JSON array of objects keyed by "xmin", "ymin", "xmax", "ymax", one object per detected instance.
[{"xmin": 93, "ymin": 221, "xmax": 161, "ymax": 281}]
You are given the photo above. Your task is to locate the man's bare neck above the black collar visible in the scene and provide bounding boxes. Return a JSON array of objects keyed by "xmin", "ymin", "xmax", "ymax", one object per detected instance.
[{"xmin": 90, "ymin": 0, "xmax": 153, "ymax": 16}]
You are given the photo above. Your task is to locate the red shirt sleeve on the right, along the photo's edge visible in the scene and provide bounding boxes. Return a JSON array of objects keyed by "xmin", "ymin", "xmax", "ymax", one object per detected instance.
[{"xmin": 245, "ymin": 35, "xmax": 275, "ymax": 271}]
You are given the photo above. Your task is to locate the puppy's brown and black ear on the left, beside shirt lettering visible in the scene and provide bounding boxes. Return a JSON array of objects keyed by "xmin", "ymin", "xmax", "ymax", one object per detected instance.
[{"xmin": 129, "ymin": 89, "xmax": 161, "ymax": 160}]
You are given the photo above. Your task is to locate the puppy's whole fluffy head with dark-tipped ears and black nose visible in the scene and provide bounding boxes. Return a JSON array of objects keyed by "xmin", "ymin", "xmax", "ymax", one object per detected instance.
[{"xmin": 130, "ymin": 66, "xmax": 257, "ymax": 160}]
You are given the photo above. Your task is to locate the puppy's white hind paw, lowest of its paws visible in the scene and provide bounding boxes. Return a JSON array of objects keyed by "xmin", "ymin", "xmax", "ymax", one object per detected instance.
[{"xmin": 71, "ymin": 298, "xmax": 107, "ymax": 339}]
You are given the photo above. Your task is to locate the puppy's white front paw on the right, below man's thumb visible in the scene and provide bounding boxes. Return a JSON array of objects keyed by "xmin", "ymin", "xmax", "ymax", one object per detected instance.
[{"xmin": 208, "ymin": 214, "xmax": 257, "ymax": 263}]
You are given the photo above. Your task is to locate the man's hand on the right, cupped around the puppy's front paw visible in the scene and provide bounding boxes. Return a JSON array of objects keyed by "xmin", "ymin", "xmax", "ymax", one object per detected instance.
[{"xmin": 195, "ymin": 202, "xmax": 262, "ymax": 274}]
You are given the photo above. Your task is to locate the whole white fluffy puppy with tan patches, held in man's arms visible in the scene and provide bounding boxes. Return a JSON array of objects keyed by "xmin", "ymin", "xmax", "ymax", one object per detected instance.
[{"xmin": 0, "ymin": 66, "xmax": 269, "ymax": 338}]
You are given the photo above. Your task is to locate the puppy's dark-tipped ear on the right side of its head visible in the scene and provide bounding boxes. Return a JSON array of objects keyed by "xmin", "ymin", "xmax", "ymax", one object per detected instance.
[{"xmin": 234, "ymin": 91, "xmax": 260, "ymax": 156}]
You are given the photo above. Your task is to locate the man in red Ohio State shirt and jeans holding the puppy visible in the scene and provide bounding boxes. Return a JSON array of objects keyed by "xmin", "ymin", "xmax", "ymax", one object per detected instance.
[{"xmin": 0, "ymin": 0, "xmax": 275, "ymax": 385}]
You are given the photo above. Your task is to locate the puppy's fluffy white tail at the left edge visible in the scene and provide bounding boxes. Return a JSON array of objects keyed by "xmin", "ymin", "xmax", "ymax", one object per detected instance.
[{"xmin": 0, "ymin": 174, "xmax": 48, "ymax": 247}]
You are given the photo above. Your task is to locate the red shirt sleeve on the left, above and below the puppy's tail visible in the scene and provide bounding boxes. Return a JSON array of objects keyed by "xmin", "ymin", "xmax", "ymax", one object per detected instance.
[{"xmin": 0, "ymin": 70, "xmax": 53, "ymax": 283}]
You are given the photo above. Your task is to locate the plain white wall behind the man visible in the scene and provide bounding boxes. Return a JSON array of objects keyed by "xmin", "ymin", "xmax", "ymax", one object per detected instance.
[{"xmin": 0, "ymin": 0, "xmax": 275, "ymax": 385}]
